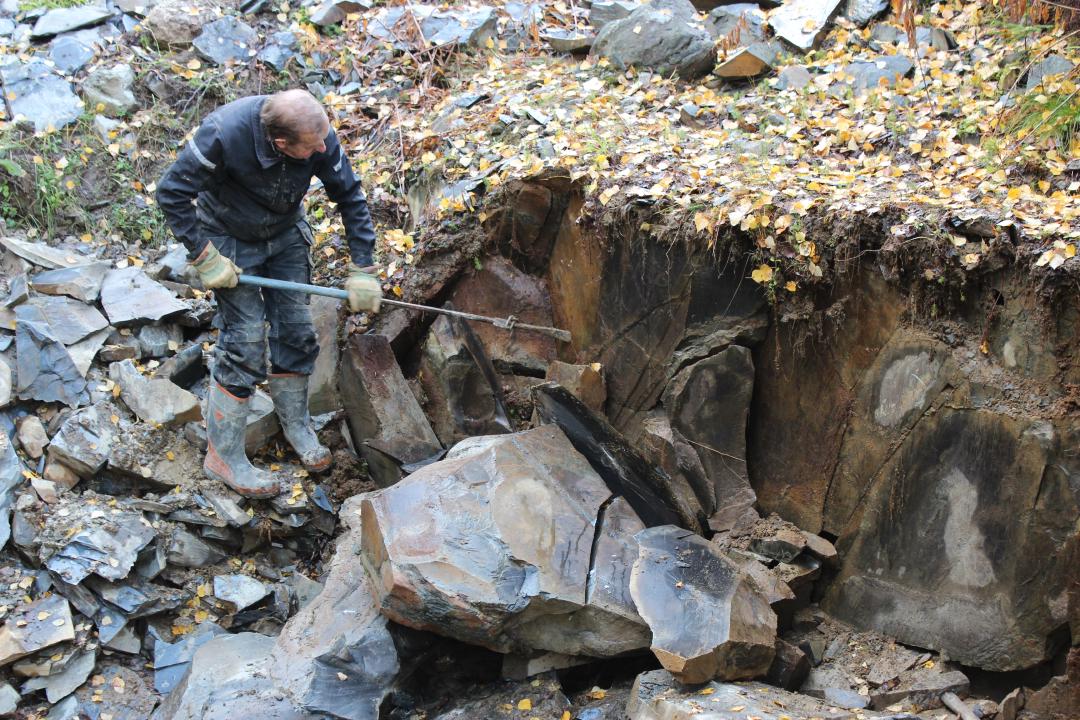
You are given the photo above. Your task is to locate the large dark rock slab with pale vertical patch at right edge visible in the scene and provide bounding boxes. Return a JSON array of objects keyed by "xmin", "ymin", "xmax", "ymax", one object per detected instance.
[{"xmin": 826, "ymin": 408, "xmax": 1080, "ymax": 671}]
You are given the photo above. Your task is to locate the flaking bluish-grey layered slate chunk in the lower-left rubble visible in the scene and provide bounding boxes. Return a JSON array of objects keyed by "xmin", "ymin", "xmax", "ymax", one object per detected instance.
[{"xmin": 45, "ymin": 513, "xmax": 158, "ymax": 585}]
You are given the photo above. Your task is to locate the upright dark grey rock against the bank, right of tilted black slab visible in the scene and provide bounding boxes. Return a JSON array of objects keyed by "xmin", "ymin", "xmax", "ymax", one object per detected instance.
[{"xmin": 663, "ymin": 345, "xmax": 757, "ymax": 520}]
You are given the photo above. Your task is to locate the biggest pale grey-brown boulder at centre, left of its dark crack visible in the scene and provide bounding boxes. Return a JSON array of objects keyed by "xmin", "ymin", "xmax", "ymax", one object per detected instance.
[{"xmin": 361, "ymin": 425, "xmax": 644, "ymax": 656}]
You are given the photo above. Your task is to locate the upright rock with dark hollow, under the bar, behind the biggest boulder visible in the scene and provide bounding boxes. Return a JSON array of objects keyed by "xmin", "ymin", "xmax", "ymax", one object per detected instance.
[{"xmin": 420, "ymin": 315, "xmax": 511, "ymax": 446}]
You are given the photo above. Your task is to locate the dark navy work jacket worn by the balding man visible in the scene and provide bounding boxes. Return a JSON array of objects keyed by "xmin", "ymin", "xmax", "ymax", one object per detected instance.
[{"xmin": 158, "ymin": 95, "xmax": 375, "ymax": 266}]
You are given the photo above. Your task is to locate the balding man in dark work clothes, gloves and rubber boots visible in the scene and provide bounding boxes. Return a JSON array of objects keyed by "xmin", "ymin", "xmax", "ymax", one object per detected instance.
[{"xmin": 158, "ymin": 90, "xmax": 381, "ymax": 498}]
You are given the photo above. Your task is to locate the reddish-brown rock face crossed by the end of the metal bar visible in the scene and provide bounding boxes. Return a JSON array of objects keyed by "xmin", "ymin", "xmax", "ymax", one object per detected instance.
[{"xmin": 450, "ymin": 257, "xmax": 557, "ymax": 377}]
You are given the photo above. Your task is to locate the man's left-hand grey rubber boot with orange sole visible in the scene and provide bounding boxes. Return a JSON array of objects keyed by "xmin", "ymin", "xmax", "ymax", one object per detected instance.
[{"xmin": 203, "ymin": 382, "xmax": 281, "ymax": 499}]
